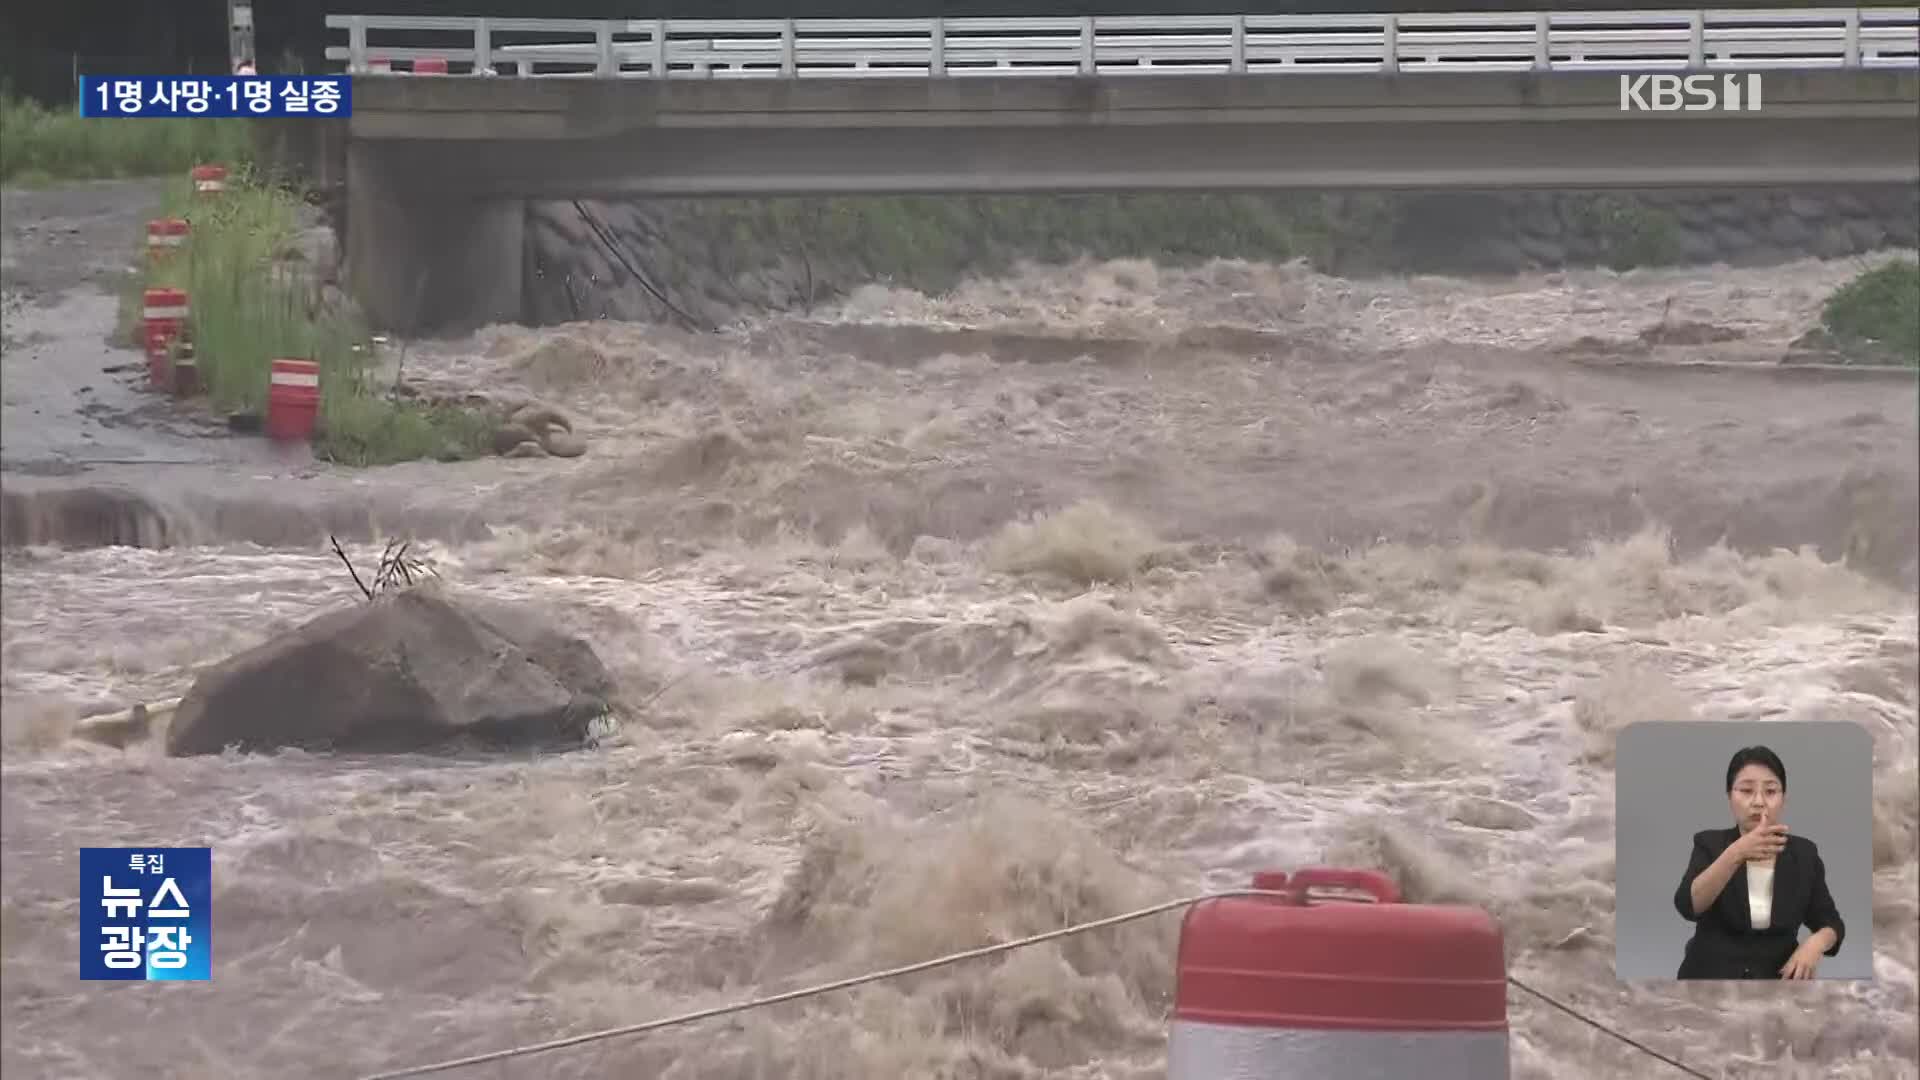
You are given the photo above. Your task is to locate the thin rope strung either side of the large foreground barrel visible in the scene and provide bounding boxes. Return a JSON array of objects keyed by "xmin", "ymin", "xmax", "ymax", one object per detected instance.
[{"xmin": 359, "ymin": 888, "xmax": 1713, "ymax": 1080}]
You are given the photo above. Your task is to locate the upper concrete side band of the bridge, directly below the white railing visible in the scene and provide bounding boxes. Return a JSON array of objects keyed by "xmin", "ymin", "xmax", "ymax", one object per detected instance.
[{"xmin": 349, "ymin": 71, "xmax": 1920, "ymax": 144}]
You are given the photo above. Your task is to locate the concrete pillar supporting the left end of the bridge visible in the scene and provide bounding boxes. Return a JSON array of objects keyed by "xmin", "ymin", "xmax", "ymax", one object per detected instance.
[{"xmin": 346, "ymin": 140, "xmax": 526, "ymax": 334}]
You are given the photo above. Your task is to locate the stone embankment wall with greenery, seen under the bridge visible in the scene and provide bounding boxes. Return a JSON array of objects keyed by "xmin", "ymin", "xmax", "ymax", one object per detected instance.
[{"xmin": 524, "ymin": 186, "xmax": 1920, "ymax": 325}]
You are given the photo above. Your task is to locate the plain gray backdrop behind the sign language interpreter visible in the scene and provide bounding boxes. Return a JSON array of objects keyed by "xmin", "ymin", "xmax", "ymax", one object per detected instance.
[{"xmin": 1613, "ymin": 721, "xmax": 1874, "ymax": 978}]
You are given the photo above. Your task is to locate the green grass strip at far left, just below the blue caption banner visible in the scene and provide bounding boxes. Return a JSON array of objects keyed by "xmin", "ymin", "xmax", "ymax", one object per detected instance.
[{"xmin": 0, "ymin": 96, "xmax": 252, "ymax": 186}]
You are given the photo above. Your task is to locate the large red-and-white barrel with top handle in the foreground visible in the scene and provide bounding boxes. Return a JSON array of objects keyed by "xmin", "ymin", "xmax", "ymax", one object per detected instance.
[{"xmin": 1167, "ymin": 869, "xmax": 1509, "ymax": 1080}]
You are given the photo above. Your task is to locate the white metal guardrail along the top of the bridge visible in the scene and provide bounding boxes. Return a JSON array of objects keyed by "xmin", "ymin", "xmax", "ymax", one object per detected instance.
[{"xmin": 326, "ymin": 8, "xmax": 1920, "ymax": 79}]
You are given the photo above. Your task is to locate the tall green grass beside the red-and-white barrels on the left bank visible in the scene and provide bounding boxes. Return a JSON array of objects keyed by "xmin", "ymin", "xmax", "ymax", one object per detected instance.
[{"xmin": 121, "ymin": 167, "xmax": 490, "ymax": 465}]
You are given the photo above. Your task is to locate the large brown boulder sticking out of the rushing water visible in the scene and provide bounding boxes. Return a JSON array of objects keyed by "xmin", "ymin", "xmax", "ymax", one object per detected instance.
[{"xmin": 167, "ymin": 586, "xmax": 614, "ymax": 755}]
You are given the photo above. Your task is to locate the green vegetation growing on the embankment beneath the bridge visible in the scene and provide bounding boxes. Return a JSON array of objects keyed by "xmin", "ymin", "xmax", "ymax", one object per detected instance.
[{"xmin": 625, "ymin": 192, "xmax": 1684, "ymax": 292}]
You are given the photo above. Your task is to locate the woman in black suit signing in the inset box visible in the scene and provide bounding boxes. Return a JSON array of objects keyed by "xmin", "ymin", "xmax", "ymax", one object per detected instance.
[{"xmin": 1674, "ymin": 746, "xmax": 1847, "ymax": 978}]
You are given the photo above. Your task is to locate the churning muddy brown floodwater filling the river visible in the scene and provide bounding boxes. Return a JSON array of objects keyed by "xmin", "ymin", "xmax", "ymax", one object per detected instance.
[{"xmin": 0, "ymin": 180, "xmax": 1920, "ymax": 1080}]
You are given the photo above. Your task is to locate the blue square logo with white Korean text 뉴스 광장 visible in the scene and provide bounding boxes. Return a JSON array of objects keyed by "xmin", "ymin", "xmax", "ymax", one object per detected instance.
[{"xmin": 81, "ymin": 847, "xmax": 213, "ymax": 982}]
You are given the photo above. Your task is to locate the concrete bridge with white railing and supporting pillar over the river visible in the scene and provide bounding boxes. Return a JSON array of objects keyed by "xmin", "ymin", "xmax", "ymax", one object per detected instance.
[{"xmin": 328, "ymin": 10, "xmax": 1920, "ymax": 329}]
